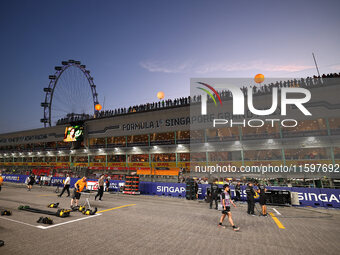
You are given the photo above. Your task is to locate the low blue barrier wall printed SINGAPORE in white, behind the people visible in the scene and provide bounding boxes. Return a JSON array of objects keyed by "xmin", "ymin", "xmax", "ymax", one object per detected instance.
[{"xmin": 2, "ymin": 174, "xmax": 340, "ymax": 208}]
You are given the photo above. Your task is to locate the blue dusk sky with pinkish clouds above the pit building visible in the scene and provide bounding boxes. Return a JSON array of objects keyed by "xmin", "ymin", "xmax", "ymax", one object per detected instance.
[{"xmin": 0, "ymin": 0, "xmax": 340, "ymax": 133}]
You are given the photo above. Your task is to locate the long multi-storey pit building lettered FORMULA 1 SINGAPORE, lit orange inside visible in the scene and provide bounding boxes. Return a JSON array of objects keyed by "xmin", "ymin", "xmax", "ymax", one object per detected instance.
[{"xmin": 0, "ymin": 74, "xmax": 340, "ymax": 188}]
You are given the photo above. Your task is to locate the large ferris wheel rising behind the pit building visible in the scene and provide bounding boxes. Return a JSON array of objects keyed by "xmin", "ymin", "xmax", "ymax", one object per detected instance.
[{"xmin": 40, "ymin": 60, "xmax": 99, "ymax": 127}]
